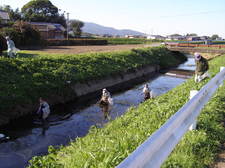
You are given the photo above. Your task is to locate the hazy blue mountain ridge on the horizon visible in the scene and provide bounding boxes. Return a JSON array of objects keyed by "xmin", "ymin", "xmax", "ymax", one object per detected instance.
[{"xmin": 82, "ymin": 22, "xmax": 145, "ymax": 36}]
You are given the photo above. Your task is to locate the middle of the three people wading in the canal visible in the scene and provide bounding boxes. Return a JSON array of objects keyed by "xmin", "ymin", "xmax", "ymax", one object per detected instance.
[{"xmin": 98, "ymin": 88, "xmax": 113, "ymax": 120}]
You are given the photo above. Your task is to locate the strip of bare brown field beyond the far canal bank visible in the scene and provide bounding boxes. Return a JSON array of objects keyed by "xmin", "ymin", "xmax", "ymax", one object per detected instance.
[{"xmin": 29, "ymin": 43, "xmax": 160, "ymax": 54}]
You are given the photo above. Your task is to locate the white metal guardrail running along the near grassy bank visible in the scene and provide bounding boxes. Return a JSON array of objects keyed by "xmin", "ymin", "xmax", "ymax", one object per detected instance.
[{"xmin": 117, "ymin": 68, "xmax": 225, "ymax": 168}]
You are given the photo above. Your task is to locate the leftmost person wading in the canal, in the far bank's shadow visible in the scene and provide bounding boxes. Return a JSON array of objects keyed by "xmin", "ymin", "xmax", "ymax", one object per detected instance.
[{"xmin": 37, "ymin": 97, "xmax": 50, "ymax": 135}]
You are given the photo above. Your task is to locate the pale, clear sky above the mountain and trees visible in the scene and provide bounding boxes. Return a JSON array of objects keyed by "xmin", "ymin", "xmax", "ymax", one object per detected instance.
[{"xmin": 0, "ymin": 0, "xmax": 225, "ymax": 38}]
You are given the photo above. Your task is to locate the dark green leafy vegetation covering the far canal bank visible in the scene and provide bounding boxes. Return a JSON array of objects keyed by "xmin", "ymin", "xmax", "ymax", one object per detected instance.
[{"xmin": 0, "ymin": 47, "xmax": 186, "ymax": 125}]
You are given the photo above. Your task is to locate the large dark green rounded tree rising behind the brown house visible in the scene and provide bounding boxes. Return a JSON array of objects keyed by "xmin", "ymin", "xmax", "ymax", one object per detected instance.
[{"xmin": 22, "ymin": 0, "xmax": 66, "ymax": 26}]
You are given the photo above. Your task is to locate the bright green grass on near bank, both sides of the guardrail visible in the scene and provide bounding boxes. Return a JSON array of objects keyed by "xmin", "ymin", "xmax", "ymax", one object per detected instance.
[{"xmin": 30, "ymin": 55, "xmax": 225, "ymax": 168}]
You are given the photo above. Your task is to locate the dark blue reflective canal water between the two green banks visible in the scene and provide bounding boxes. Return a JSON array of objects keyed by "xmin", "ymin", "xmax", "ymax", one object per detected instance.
[{"xmin": 0, "ymin": 58, "xmax": 195, "ymax": 168}]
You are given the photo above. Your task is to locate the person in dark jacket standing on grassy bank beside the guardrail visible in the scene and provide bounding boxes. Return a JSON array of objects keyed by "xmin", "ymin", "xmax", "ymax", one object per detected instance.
[{"xmin": 194, "ymin": 53, "xmax": 209, "ymax": 82}]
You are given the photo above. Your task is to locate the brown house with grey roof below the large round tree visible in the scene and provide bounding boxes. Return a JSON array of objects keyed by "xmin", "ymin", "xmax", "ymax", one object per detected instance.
[{"xmin": 29, "ymin": 22, "xmax": 66, "ymax": 39}]
